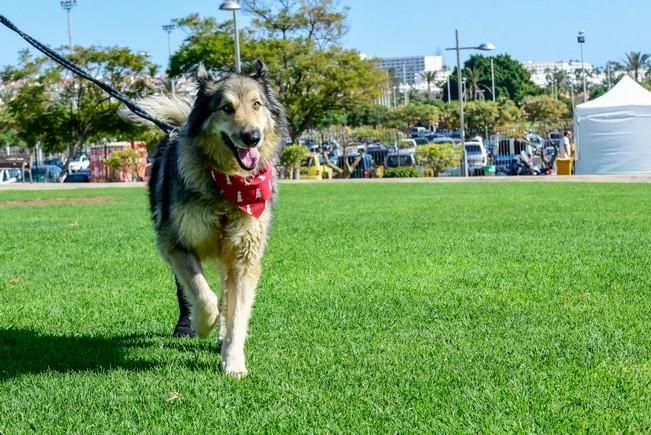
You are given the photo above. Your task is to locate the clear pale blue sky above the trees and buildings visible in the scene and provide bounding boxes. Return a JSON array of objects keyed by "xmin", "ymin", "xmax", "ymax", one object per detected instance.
[{"xmin": 0, "ymin": 0, "xmax": 651, "ymax": 71}]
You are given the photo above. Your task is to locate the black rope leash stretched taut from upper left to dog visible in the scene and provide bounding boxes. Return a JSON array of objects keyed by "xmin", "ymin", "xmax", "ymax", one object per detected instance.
[{"xmin": 0, "ymin": 15, "xmax": 176, "ymax": 134}]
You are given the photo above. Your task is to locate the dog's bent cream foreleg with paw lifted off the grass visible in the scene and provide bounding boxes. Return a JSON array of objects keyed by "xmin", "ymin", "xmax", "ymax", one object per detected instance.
[{"xmin": 166, "ymin": 249, "xmax": 219, "ymax": 338}]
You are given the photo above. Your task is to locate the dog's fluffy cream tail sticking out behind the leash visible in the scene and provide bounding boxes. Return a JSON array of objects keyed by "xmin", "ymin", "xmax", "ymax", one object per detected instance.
[{"xmin": 120, "ymin": 95, "xmax": 192, "ymax": 127}]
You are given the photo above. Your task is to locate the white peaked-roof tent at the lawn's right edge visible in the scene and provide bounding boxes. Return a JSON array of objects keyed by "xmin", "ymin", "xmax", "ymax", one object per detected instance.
[{"xmin": 574, "ymin": 76, "xmax": 651, "ymax": 175}]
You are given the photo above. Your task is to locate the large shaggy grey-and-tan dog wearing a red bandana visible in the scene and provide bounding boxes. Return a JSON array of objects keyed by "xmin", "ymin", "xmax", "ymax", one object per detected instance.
[{"xmin": 132, "ymin": 61, "xmax": 287, "ymax": 377}]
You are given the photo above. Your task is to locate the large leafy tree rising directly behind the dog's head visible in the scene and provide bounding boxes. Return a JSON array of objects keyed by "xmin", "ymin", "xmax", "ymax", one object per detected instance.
[{"xmin": 170, "ymin": 5, "xmax": 386, "ymax": 142}]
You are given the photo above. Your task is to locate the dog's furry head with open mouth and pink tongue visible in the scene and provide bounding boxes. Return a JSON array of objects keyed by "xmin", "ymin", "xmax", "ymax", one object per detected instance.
[{"xmin": 186, "ymin": 61, "xmax": 285, "ymax": 174}]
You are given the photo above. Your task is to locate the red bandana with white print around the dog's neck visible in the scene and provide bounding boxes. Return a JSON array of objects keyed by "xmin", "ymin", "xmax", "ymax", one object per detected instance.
[{"xmin": 210, "ymin": 163, "xmax": 273, "ymax": 219}]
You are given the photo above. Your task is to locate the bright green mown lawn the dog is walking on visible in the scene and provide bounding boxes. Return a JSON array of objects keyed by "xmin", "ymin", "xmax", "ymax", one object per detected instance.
[{"xmin": 0, "ymin": 183, "xmax": 651, "ymax": 434}]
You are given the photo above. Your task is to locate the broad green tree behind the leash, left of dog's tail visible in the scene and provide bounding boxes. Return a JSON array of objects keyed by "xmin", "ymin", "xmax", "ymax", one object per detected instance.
[{"xmin": 1, "ymin": 46, "xmax": 156, "ymax": 165}]
